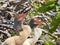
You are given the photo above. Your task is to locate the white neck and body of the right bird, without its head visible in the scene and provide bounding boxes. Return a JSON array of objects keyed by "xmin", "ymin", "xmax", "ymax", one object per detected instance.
[{"xmin": 23, "ymin": 27, "xmax": 43, "ymax": 45}]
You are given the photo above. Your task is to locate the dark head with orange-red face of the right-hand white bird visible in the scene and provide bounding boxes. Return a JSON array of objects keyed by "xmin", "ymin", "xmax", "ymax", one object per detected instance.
[{"xmin": 29, "ymin": 16, "xmax": 43, "ymax": 28}]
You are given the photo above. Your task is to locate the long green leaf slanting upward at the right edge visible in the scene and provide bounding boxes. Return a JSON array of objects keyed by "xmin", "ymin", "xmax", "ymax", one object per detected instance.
[{"xmin": 49, "ymin": 13, "xmax": 60, "ymax": 33}]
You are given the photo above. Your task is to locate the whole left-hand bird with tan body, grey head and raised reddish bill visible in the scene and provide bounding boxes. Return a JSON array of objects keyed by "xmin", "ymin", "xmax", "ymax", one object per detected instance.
[{"xmin": 1, "ymin": 5, "xmax": 32, "ymax": 45}]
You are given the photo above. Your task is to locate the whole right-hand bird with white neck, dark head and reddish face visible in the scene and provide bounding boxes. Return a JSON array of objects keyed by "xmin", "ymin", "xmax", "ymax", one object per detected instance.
[{"xmin": 23, "ymin": 16, "xmax": 43, "ymax": 45}]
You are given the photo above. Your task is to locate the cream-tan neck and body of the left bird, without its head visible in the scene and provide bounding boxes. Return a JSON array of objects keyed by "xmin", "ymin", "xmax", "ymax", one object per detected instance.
[{"xmin": 1, "ymin": 25, "xmax": 31, "ymax": 45}]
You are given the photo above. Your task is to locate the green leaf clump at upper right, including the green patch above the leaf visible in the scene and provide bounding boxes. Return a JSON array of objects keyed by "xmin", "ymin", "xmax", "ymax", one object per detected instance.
[{"xmin": 37, "ymin": 1, "xmax": 55, "ymax": 13}]
